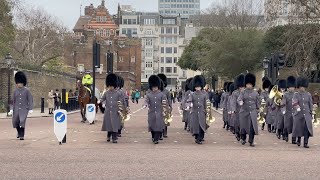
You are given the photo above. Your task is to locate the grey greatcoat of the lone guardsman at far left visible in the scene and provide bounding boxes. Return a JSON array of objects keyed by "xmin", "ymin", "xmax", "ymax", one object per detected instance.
[{"xmin": 12, "ymin": 87, "xmax": 33, "ymax": 128}]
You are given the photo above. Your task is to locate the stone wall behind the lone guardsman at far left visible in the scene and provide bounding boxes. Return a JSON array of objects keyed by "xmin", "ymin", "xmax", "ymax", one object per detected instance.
[{"xmin": 0, "ymin": 69, "xmax": 76, "ymax": 108}]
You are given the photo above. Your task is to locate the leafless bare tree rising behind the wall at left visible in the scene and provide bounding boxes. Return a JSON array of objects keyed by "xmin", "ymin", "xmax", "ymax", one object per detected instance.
[{"xmin": 13, "ymin": 6, "xmax": 66, "ymax": 67}]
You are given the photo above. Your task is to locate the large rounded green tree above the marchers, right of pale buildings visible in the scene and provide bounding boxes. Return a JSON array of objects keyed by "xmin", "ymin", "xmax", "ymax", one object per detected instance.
[{"xmin": 178, "ymin": 28, "xmax": 263, "ymax": 78}]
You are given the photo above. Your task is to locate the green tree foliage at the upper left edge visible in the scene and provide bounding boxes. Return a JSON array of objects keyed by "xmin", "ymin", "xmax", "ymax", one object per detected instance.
[{"xmin": 0, "ymin": 0, "xmax": 14, "ymax": 58}]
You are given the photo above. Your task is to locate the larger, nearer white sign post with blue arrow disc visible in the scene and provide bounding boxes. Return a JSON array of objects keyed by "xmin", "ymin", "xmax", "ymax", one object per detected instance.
[{"xmin": 53, "ymin": 109, "xmax": 68, "ymax": 145}]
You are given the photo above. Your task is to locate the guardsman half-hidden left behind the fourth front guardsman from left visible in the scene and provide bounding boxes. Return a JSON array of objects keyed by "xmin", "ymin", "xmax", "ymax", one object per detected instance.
[{"xmin": 181, "ymin": 78, "xmax": 192, "ymax": 132}]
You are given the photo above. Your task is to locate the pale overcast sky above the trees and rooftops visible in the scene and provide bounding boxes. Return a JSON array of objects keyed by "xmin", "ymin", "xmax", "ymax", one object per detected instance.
[{"xmin": 26, "ymin": 0, "xmax": 216, "ymax": 30}]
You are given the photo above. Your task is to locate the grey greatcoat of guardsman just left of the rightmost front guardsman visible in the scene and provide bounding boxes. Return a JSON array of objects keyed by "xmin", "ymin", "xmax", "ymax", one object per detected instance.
[{"xmin": 281, "ymin": 91, "xmax": 294, "ymax": 134}]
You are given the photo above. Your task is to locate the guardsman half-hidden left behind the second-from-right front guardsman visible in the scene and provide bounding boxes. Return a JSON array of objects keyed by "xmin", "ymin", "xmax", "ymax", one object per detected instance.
[{"xmin": 230, "ymin": 74, "xmax": 245, "ymax": 141}]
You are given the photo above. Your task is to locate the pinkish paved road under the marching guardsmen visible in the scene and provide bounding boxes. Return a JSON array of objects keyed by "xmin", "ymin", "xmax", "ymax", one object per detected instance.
[{"xmin": 0, "ymin": 100, "xmax": 320, "ymax": 180}]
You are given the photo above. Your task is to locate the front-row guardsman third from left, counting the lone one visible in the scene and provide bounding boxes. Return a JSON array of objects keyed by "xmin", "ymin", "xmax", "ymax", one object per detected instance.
[{"xmin": 143, "ymin": 75, "xmax": 170, "ymax": 144}]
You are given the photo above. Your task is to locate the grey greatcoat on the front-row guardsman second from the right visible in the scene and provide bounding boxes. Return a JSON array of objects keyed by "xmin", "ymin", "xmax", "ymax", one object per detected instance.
[{"xmin": 238, "ymin": 89, "xmax": 260, "ymax": 135}]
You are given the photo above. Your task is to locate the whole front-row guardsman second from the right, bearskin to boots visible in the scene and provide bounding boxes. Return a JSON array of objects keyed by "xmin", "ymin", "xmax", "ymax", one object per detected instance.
[{"xmin": 238, "ymin": 73, "xmax": 260, "ymax": 147}]
